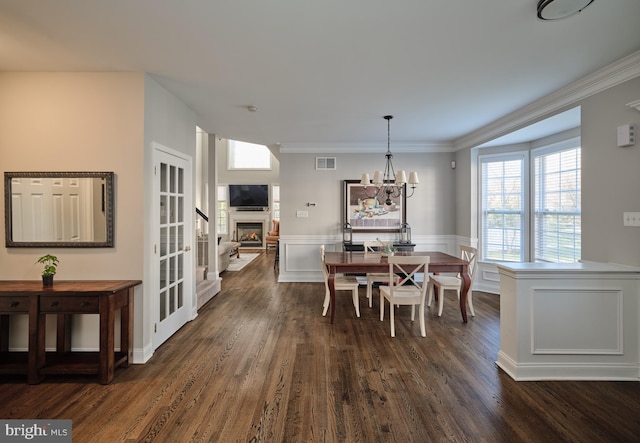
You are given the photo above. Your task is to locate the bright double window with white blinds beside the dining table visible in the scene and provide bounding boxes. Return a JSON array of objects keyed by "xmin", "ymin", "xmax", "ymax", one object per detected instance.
[{"xmin": 479, "ymin": 140, "xmax": 581, "ymax": 263}]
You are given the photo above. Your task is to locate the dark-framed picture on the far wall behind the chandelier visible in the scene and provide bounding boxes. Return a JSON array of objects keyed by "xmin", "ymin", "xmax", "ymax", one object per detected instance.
[{"xmin": 343, "ymin": 180, "xmax": 407, "ymax": 232}]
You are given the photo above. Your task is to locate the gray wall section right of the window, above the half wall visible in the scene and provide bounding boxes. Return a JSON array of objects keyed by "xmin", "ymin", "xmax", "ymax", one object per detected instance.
[{"xmin": 581, "ymin": 77, "xmax": 640, "ymax": 266}]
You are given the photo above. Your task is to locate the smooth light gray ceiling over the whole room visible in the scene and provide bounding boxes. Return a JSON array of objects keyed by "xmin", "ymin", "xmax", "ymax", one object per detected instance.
[{"xmin": 0, "ymin": 0, "xmax": 640, "ymax": 151}]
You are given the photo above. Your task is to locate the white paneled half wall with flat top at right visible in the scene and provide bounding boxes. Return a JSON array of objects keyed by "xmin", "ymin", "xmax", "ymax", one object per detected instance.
[{"xmin": 496, "ymin": 262, "xmax": 640, "ymax": 382}]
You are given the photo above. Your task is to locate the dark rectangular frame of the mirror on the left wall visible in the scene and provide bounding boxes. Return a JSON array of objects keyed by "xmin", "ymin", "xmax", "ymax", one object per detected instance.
[{"xmin": 4, "ymin": 172, "xmax": 114, "ymax": 248}]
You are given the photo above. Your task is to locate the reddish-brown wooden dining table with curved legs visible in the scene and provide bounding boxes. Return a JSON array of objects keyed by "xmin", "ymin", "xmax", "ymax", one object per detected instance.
[{"xmin": 325, "ymin": 251, "xmax": 471, "ymax": 324}]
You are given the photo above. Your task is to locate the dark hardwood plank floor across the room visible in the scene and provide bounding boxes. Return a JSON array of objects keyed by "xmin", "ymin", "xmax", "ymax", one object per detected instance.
[{"xmin": 0, "ymin": 250, "xmax": 640, "ymax": 442}]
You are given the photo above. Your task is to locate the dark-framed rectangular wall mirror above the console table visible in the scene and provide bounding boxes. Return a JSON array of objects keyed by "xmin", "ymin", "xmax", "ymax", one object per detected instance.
[{"xmin": 4, "ymin": 172, "xmax": 114, "ymax": 248}]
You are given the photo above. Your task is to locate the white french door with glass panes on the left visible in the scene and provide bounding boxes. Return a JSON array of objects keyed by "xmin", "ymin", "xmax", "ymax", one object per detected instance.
[{"xmin": 153, "ymin": 149, "xmax": 195, "ymax": 349}]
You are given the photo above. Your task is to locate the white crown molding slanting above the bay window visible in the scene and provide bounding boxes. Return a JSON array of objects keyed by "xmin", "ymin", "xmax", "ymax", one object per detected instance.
[{"xmin": 452, "ymin": 51, "xmax": 640, "ymax": 151}]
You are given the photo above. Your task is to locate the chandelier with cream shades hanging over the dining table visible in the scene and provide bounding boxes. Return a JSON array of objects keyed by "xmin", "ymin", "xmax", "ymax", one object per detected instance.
[{"xmin": 360, "ymin": 115, "xmax": 420, "ymax": 205}]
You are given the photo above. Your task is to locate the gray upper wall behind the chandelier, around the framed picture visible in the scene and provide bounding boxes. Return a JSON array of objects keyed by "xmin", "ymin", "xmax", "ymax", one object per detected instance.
[{"xmin": 280, "ymin": 151, "xmax": 456, "ymax": 240}]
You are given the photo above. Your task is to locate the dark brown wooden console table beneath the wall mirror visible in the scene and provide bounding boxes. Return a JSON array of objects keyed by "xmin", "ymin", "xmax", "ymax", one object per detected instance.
[{"xmin": 0, "ymin": 280, "xmax": 142, "ymax": 384}]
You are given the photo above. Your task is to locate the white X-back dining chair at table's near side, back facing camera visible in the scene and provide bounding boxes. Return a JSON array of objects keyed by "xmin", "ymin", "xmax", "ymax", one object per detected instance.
[{"xmin": 379, "ymin": 255, "xmax": 430, "ymax": 337}]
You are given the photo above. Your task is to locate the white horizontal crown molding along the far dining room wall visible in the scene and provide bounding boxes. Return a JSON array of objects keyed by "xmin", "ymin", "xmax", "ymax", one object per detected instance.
[{"xmin": 280, "ymin": 142, "xmax": 455, "ymax": 154}]
